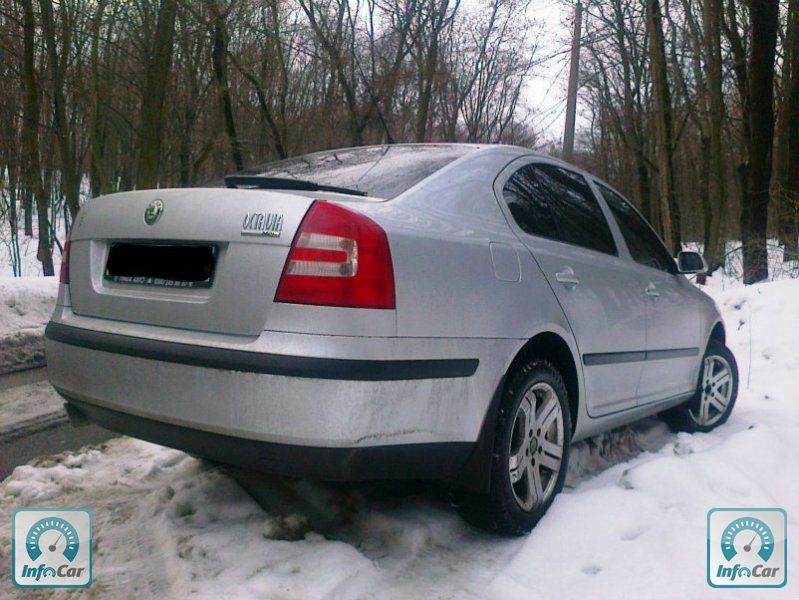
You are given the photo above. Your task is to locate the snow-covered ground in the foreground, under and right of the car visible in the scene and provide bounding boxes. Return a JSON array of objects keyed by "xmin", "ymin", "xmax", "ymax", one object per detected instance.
[{"xmin": 0, "ymin": 277, "xmax": 799, "ymax": 600}]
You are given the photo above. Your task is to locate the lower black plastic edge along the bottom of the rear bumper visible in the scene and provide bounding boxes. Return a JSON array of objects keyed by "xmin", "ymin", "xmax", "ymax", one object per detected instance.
[{"xmin": 64, "ymin": 398, "xmax": 474, "ymax": 481}]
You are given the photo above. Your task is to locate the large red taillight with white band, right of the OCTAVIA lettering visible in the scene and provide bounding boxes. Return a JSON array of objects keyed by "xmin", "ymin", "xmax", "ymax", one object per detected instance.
[{"xmin": 275, "ymin": 200, "xmax": 396, "ymax": 309}]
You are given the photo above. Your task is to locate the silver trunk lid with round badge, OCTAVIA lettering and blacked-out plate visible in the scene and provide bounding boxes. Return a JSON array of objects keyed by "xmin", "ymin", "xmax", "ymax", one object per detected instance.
[{"xmin": 70, "ymin": 188, "xmax": 313, "ymax": 336}]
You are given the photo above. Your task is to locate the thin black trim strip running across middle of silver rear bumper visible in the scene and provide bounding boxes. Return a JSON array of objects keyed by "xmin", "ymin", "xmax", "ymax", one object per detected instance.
[{"xmin": 44, "ymin": 322, "xmax": 479, "ymax": 381}]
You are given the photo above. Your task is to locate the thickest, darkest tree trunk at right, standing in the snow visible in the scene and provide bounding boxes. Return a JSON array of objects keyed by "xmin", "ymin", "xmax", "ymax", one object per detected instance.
[{"xmin": 741, "ymin": 0, "xmax": 779, "ymax": 284}]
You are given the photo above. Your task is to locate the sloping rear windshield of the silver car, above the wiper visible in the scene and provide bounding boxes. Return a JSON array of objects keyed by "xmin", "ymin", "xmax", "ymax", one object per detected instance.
[{"xmin": 242, "ymin": 144, "xmax": 478, "ymax": 199}]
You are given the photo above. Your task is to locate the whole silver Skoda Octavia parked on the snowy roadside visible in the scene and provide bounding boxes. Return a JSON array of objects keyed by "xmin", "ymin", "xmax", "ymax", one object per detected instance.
[{"xmin": 46, "ymin": 145, "xmax": 737, "ymax": 534}]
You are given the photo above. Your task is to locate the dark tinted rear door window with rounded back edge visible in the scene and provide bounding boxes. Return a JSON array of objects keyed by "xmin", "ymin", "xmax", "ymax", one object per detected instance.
[{"xmin": 503, "ymin": 164, "xmax": 616, "ymax": 254}]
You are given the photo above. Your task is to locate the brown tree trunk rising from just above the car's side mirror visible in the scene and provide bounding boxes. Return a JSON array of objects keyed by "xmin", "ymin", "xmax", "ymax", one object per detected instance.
[{"xmin": 647, "ymin": 0, "xmax": 680, "ymax": 254}]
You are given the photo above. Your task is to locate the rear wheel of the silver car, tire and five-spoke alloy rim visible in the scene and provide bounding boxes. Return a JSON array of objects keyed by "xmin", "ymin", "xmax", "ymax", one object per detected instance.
[{"xmin": 459, "ymin": 360, "xmax": 572, "ymax": 535}]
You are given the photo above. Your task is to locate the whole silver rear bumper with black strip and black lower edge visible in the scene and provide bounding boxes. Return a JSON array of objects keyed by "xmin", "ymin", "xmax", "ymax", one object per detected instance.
[{"xmin": 46, "ymin": 306, "xmax": 517, "ymax": 479}]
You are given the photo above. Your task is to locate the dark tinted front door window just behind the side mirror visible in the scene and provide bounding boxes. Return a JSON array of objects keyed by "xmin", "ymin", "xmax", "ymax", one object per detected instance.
[{"xmin": 597, "ymin": 183, "xmax": 677, "ymax": 273}]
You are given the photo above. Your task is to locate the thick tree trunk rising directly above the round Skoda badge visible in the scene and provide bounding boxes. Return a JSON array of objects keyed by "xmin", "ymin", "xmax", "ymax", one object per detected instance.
[{"xmin": 136, "ymin": 0, "xmax": 177, "ymax": 189}]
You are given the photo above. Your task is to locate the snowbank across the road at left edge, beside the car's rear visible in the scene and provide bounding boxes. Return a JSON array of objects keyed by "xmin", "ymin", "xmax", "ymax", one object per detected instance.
[{"xmin": 0, "ymin": 277, "xmax": 58, "ymax": 373}]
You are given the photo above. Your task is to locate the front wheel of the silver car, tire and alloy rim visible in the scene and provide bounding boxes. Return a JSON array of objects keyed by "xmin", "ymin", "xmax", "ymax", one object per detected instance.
[{"xmin": 661, "ymin": 340, "xmax": 738, "ymax": 433}]
